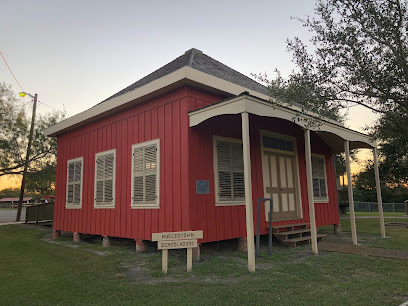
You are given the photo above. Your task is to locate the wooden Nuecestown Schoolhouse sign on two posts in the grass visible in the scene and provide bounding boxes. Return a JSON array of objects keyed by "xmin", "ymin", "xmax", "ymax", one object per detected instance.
[{"xmin": 152, "ymin": 231, "xmax": 203, "ymax": 273}]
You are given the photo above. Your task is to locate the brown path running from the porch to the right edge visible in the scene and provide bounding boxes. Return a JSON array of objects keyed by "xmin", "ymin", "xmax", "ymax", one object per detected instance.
[{"xmin": 319, "ymin": 242, "xmax": 408, "ymax": 260}]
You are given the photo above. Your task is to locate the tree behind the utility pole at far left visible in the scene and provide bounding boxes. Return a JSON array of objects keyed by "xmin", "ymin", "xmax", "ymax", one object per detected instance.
[{"xmin": 0, "ymin": 82, "xmax": 64, "ymax": 176}]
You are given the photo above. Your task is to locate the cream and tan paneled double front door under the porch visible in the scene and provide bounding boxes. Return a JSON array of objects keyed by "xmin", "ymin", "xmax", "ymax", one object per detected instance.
[{"xmin": 262, "ymin": 150, "xmax": 299, "ymax": 221}]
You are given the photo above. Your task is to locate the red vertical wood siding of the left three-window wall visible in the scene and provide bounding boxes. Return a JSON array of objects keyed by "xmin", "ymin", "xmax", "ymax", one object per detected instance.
[{"xmin": 54, "ymin": 87, "xmax": 198, "ymax": 240}]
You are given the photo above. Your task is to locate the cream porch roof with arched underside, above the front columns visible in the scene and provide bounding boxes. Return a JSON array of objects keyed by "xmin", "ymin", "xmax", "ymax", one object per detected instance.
[{"xmin": 189, "ymin": 92, "xmax": 377, "ymax": 153}]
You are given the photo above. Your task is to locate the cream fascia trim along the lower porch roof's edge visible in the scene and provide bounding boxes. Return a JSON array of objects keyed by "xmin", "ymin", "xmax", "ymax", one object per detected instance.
[{"xmin": 189, "ymin": 95, "xmax": 377, "ymax": 148}]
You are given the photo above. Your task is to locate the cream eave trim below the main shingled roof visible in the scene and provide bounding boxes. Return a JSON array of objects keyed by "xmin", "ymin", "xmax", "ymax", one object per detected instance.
[{"xmin": 44, "ymin": 66, "xmax": 341, "ymax": 136}]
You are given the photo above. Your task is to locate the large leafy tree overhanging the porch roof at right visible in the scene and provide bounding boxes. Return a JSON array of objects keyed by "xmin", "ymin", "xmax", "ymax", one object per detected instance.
[{"xmin": 267, "ymin": 0, "xmax": 408, "ymax": 184}]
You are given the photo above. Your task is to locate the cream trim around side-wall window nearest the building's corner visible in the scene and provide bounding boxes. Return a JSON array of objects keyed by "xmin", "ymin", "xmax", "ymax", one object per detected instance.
[{"xmin": 130, "ymin": 138, "xmax": 160, "ymax": 209}]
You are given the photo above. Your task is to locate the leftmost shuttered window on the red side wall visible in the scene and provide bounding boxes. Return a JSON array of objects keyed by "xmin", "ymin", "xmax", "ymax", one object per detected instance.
[{"xmin": 66, "ymin": 157, "xmax": 84, "ymax": 208}]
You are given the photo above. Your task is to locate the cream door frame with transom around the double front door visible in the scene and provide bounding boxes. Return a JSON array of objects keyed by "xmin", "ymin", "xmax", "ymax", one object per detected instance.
[{"xmin": 259, "ymin": 129, "xmax": 303, "ymax": 221}]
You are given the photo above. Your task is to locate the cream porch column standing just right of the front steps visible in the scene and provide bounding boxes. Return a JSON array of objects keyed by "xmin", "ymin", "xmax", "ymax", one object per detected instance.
[{"xmin": 305, "ymin": 129, "xmax": 319, "ymax": 255}]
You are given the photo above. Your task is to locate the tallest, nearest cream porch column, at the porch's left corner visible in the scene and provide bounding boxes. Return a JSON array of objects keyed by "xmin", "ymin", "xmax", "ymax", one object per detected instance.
[{"xmin": 241, "ymin": 112, "xmax": 255, "ymax": 272}]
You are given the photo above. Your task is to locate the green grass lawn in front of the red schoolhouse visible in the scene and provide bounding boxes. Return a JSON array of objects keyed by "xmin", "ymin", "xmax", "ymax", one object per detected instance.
[{"xmin": 0, "ymin": 220, "xmax": 408, "ymax": 305}]
